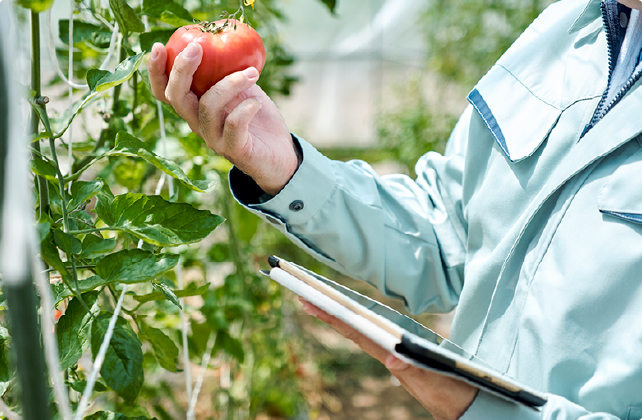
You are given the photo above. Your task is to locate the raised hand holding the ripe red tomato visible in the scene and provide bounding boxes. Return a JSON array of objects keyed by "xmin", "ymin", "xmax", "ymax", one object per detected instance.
[{"xmin": 147, "ymin": 43, "xmax": 299, "ymax": 195}]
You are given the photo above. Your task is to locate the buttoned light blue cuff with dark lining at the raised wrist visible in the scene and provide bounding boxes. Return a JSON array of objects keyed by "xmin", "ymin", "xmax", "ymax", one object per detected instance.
[{"xmin": 229, "ymin": 136, "xmax": 336, "ymax": 225}]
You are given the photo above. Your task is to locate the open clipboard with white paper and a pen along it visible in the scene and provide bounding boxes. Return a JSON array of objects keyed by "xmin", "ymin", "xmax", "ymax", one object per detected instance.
[{"xmin": 262, "ymin": 255, "xmax": 547, "ymax": 409}]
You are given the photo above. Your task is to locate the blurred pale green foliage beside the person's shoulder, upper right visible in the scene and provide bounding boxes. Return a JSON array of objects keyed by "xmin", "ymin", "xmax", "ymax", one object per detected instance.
[{"xmin": 378, "ymin": 0, "xmax": 553, "ymax": 175}]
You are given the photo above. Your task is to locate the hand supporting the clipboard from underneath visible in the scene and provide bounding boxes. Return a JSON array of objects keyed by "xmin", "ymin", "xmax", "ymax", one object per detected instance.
[{"xmin": 299, "ymin": 298, "xmax": 478, "ymax": 420}]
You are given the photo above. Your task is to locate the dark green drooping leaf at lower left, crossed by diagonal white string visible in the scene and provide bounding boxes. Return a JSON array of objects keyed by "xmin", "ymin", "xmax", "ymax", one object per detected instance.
[{"xmin": 91, "ymin": 312, "xmax": 144, "ymax": 402}]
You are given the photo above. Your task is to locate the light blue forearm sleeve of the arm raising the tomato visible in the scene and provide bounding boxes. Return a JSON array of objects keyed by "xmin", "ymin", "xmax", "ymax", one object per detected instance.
[{"xmin": 230, "ymin": 113, "xmax": 466, "ymax": 313}]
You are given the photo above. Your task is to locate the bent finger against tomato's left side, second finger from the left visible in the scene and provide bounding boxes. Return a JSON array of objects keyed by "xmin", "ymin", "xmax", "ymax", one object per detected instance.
[{"xmin": 165, "ymin": 42, "xmax": 203, "ymax": 134}]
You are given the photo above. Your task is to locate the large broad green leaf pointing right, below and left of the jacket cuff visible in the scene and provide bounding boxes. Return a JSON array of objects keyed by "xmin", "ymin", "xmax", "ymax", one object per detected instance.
[{"xmin": 96, "ymin": 193, "xmax": 224, "ymax": 246}]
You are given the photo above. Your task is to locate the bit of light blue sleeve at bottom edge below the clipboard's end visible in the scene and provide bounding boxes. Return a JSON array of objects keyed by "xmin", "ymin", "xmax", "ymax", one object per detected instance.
[{"xmin": 459, "ymin": 391, "xmax": 624, "ymax": 420}]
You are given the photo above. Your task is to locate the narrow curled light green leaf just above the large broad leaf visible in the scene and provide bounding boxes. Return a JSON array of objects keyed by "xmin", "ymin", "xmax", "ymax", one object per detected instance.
[{"xmin": 107, "ymin": 131, "xmax": 213, "ymax": 192}]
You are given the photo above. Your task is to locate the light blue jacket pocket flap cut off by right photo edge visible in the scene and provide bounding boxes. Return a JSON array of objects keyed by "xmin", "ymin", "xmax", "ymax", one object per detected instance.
[{"xmin": 597, "ymin": 144, "xmax": 642, "ymax": 224}]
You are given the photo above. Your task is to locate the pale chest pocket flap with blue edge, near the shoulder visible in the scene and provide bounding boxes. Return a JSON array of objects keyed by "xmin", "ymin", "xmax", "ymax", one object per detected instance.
[{"xmin": 468, "ymin": 65, "xmax": 562, "ymax": 162}]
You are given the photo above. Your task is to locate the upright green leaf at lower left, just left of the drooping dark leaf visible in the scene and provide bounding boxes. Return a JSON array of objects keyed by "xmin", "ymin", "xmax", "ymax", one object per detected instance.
[{"xmin": 56, "ymin": 292, "xmax": 100, "ymax": 370}]
